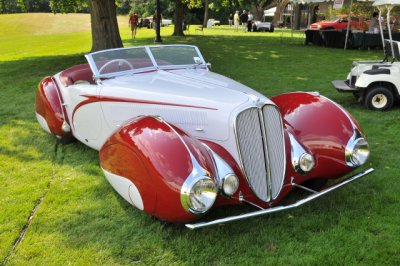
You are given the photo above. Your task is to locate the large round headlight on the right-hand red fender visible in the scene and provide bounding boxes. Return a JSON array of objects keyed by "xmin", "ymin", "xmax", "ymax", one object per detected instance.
[{"xmin": 346, "ymin": 137, "xmax": 369, "ymax": 167}]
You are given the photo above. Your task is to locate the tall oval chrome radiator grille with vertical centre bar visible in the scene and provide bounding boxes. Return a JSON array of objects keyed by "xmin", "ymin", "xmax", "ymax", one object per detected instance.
[{"xmin": 236, "ymin": 105, "xmax": 286, "ymax": 201}]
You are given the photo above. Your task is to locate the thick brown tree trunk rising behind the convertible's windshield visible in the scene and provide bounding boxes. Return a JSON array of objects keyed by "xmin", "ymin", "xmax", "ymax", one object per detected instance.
[{"xmin": 89, "ymin": 0, "xmax": 123, "ymax": 52}]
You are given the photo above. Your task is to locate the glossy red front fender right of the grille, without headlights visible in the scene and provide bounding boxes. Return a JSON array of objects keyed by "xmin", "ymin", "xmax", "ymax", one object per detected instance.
[{"xmin": 271, "ymin": 92, "xmax": 361, "ymax": 178}]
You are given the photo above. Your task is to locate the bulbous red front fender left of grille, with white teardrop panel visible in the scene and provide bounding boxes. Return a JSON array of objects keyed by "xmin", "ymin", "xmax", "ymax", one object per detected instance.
[{"xmin": 100, "ymin": 116, "xmax": 215, "ymax": 222}]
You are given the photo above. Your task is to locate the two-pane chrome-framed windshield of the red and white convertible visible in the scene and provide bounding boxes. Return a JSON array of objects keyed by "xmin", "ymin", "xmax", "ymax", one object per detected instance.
[{"xmin": 86, "ymin": 45, "xmax": 206, "ymax": 78}]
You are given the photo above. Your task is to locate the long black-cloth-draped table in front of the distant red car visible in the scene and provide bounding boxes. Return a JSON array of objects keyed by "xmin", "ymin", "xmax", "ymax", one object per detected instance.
[{"xmin": 305, "ymin": 30, "xmax": 400, "ymax": 50}]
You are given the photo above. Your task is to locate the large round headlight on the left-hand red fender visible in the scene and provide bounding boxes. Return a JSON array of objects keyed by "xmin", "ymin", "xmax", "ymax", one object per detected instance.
[{"xmin": 181, "ymin": 176, "xmax": 218, "ymax": 214}]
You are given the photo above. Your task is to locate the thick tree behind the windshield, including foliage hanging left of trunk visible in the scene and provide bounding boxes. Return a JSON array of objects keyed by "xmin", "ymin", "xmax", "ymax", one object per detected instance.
[{"xmin": 50, "ymin": 0, "xmax": 123, "ymax": 52}]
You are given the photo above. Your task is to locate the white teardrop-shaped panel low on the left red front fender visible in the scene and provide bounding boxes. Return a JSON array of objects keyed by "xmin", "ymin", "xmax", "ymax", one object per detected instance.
[{"xmin": 102, "ymin": 168, "xmax": 144, "ymax": 211}]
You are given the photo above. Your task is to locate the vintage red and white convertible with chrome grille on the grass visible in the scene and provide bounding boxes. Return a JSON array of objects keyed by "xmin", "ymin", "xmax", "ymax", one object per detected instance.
[{"xmin": 36, "ymin": 45, "xmax": 373, "ymax": 229}]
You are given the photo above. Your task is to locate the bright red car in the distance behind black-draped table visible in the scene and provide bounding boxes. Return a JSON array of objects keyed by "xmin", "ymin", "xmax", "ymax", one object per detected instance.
[{"xmin": 310, "ymin": 15, "xmax": 367, "ymax": 30}]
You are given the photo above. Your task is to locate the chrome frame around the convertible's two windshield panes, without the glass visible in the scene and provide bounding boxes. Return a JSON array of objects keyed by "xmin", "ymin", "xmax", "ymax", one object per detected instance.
[{"xmin": 85, "ymin": 44, "xmax": 208, "ymax": 82}]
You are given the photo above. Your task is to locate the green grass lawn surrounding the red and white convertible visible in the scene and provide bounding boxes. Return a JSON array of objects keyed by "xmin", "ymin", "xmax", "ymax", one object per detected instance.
[{"xmin": 0, "ymin": 14, "xmax": 400, "ymax": 265}]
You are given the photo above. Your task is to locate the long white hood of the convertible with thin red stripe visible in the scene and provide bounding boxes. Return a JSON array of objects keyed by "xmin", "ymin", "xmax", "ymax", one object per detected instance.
[{"xmin": 100, "ymin": 69, "xmax": 272, "ymax": 141}]
